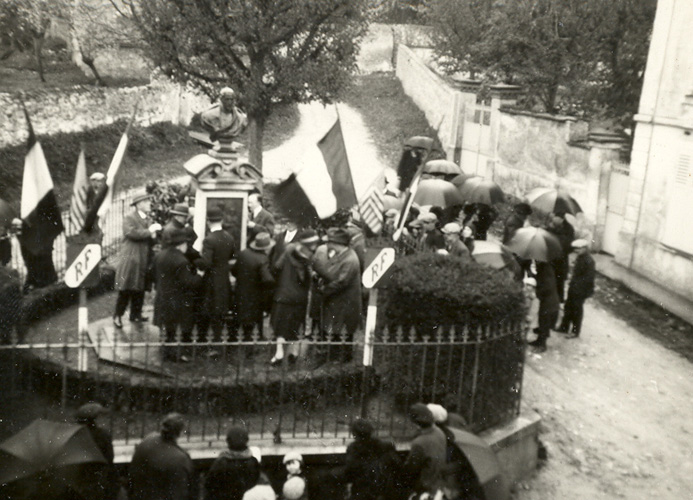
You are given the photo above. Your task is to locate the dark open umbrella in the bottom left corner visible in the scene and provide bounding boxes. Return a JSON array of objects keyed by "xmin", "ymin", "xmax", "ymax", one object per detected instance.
[{"xmin": 0, "ymin": 419, "xmax": 106, "ymax": 499}]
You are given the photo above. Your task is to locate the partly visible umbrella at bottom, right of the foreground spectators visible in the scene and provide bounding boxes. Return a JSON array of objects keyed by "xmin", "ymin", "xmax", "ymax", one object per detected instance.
[{"xmin": 449, "ymin": 427, "xmax": 510, "ymax": 500}]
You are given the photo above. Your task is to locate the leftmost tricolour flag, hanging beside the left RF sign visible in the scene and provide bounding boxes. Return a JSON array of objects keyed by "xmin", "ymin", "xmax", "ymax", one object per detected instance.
[{"xmin": 19, "ymin": 107, "xmax": 64, "ymax": 255}]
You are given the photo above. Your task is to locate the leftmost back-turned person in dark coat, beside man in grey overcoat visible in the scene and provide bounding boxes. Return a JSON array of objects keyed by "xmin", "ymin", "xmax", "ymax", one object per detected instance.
[{"xmin": 154, "ymin": 229, "xmax": 202, "ymax": 361}]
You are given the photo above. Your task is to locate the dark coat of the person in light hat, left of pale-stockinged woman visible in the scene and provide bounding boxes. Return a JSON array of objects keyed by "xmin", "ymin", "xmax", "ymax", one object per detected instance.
[{"xmin": 231, "ymin": 248, "xmax": 274, "ymax": 325}]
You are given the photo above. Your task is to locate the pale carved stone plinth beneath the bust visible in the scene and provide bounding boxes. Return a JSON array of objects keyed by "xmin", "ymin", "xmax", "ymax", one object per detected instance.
[{"xmin": 184, "ymin": 147, "xmax": 262, "ymax": 251}]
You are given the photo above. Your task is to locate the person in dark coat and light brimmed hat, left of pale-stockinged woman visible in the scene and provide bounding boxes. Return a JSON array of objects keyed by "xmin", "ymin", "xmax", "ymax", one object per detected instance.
[{"xmin": 231, "ymin": 233, "xmax": 274, "ymax": 341}]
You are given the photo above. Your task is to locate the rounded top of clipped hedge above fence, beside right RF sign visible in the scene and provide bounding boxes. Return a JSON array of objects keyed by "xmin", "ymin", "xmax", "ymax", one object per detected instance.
[{"xmin": 384, "ymin": 253, "xmax": 525, "ymax": 333}]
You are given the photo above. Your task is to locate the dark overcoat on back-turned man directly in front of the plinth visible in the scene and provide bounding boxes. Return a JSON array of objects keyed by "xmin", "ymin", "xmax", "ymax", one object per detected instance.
[{"xmin": 199, "ymin": 229, "xmax": 235, "ymax": 314}]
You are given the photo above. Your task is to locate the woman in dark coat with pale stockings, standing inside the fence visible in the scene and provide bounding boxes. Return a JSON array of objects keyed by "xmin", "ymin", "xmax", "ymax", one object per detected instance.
[{"xmin": 271, "ymin": 229, "xmax": 320, "ymax": 364}]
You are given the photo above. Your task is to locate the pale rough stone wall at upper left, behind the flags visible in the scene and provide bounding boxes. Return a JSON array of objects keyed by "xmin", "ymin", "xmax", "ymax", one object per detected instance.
[{"xmin": 0, "ymin": 80, "xmax": 210, "ymax": 148}]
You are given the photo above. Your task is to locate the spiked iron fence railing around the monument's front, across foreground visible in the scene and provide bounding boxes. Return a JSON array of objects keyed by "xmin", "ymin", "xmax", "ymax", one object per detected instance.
[{"xmin": 0, "ymin": 318, "xmax": 526, "ymax": 443}]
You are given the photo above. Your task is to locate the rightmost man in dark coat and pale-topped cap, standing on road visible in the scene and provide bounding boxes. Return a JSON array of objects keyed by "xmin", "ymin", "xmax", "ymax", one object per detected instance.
[{"xmin": 556, "ymin": 239, "xmax": 596, "ymax": 338}]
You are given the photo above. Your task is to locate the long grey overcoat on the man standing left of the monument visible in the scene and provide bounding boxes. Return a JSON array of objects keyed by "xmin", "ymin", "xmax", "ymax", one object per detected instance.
[{"xmin": 115, "ymin": 210, "xmax": 152, "ymax": 290}]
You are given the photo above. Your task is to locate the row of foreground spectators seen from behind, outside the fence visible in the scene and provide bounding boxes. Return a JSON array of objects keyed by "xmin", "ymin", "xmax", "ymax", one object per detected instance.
[{"xmin": 60, "ymin": 403, "xmax": 483, "ymax": 500}]
